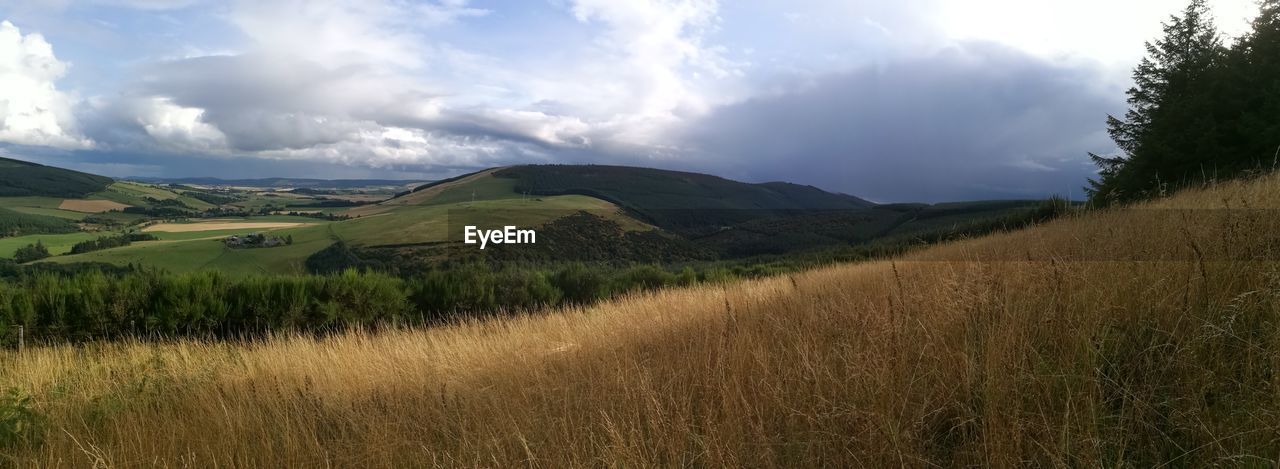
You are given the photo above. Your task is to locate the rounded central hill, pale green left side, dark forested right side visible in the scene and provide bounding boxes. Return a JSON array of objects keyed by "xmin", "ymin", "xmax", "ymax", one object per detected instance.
[{"xmin": 329, "ymin": 165, "xmax": 1039, "ymax": 269}]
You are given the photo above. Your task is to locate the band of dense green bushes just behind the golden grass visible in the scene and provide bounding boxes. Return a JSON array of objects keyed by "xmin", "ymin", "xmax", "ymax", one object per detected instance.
[{"xmin": 0, "ymin": 264, "xmax": 798, "ymax": 345}]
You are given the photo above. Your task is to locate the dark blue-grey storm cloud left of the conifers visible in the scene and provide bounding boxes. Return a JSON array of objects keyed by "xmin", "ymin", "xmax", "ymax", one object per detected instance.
[{"xmin": 684, "ymin": 44, "xmax": 1123, "ymax": 201}]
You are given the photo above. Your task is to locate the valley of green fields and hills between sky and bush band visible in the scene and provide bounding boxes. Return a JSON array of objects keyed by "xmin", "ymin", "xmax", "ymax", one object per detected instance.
[{"xmin": 0, "ymin": 159, "xmax": 1059, "ymax": 274}]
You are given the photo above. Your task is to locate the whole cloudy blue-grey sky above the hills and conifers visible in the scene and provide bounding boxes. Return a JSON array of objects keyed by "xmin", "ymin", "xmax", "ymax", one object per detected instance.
[{"xmin": 0, "ymin": 0, "xmax": 1256, "ymax": 201}]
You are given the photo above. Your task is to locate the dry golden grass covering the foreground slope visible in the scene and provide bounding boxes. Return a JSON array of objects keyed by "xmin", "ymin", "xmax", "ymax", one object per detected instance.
[{"xmin": 0, "ymin": 177, "xmax": 1280, "ymax": 468}]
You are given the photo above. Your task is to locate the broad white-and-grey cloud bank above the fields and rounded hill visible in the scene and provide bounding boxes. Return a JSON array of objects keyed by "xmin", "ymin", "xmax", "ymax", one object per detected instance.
[{"xmin": 82, "ymin": 0, "xmax": 737, "ymax": 167}]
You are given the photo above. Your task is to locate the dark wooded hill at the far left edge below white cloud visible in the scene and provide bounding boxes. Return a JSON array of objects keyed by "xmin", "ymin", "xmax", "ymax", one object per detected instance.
[{"xmin": 0, "ymin": 158, "xmax": 115, "ymax": 199}]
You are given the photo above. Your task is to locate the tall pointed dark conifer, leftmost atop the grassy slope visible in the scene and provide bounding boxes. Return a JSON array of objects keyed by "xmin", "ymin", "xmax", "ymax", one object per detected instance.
[{"xmin": 1085, "ymin": 0, "xmax": 1225, "ymax": 204}]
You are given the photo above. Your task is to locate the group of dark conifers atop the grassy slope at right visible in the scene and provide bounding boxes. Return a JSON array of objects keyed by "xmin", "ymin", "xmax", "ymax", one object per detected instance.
[{"xmin": 1087, "ymin": 0, "xmax": 1280, "ymax": 205}]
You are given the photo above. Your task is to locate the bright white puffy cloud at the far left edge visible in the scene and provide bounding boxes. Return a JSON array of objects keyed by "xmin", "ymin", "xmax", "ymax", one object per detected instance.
[{"xmin": 0, "ymin": 22, "xmax": 92, "ymax": 149}]
